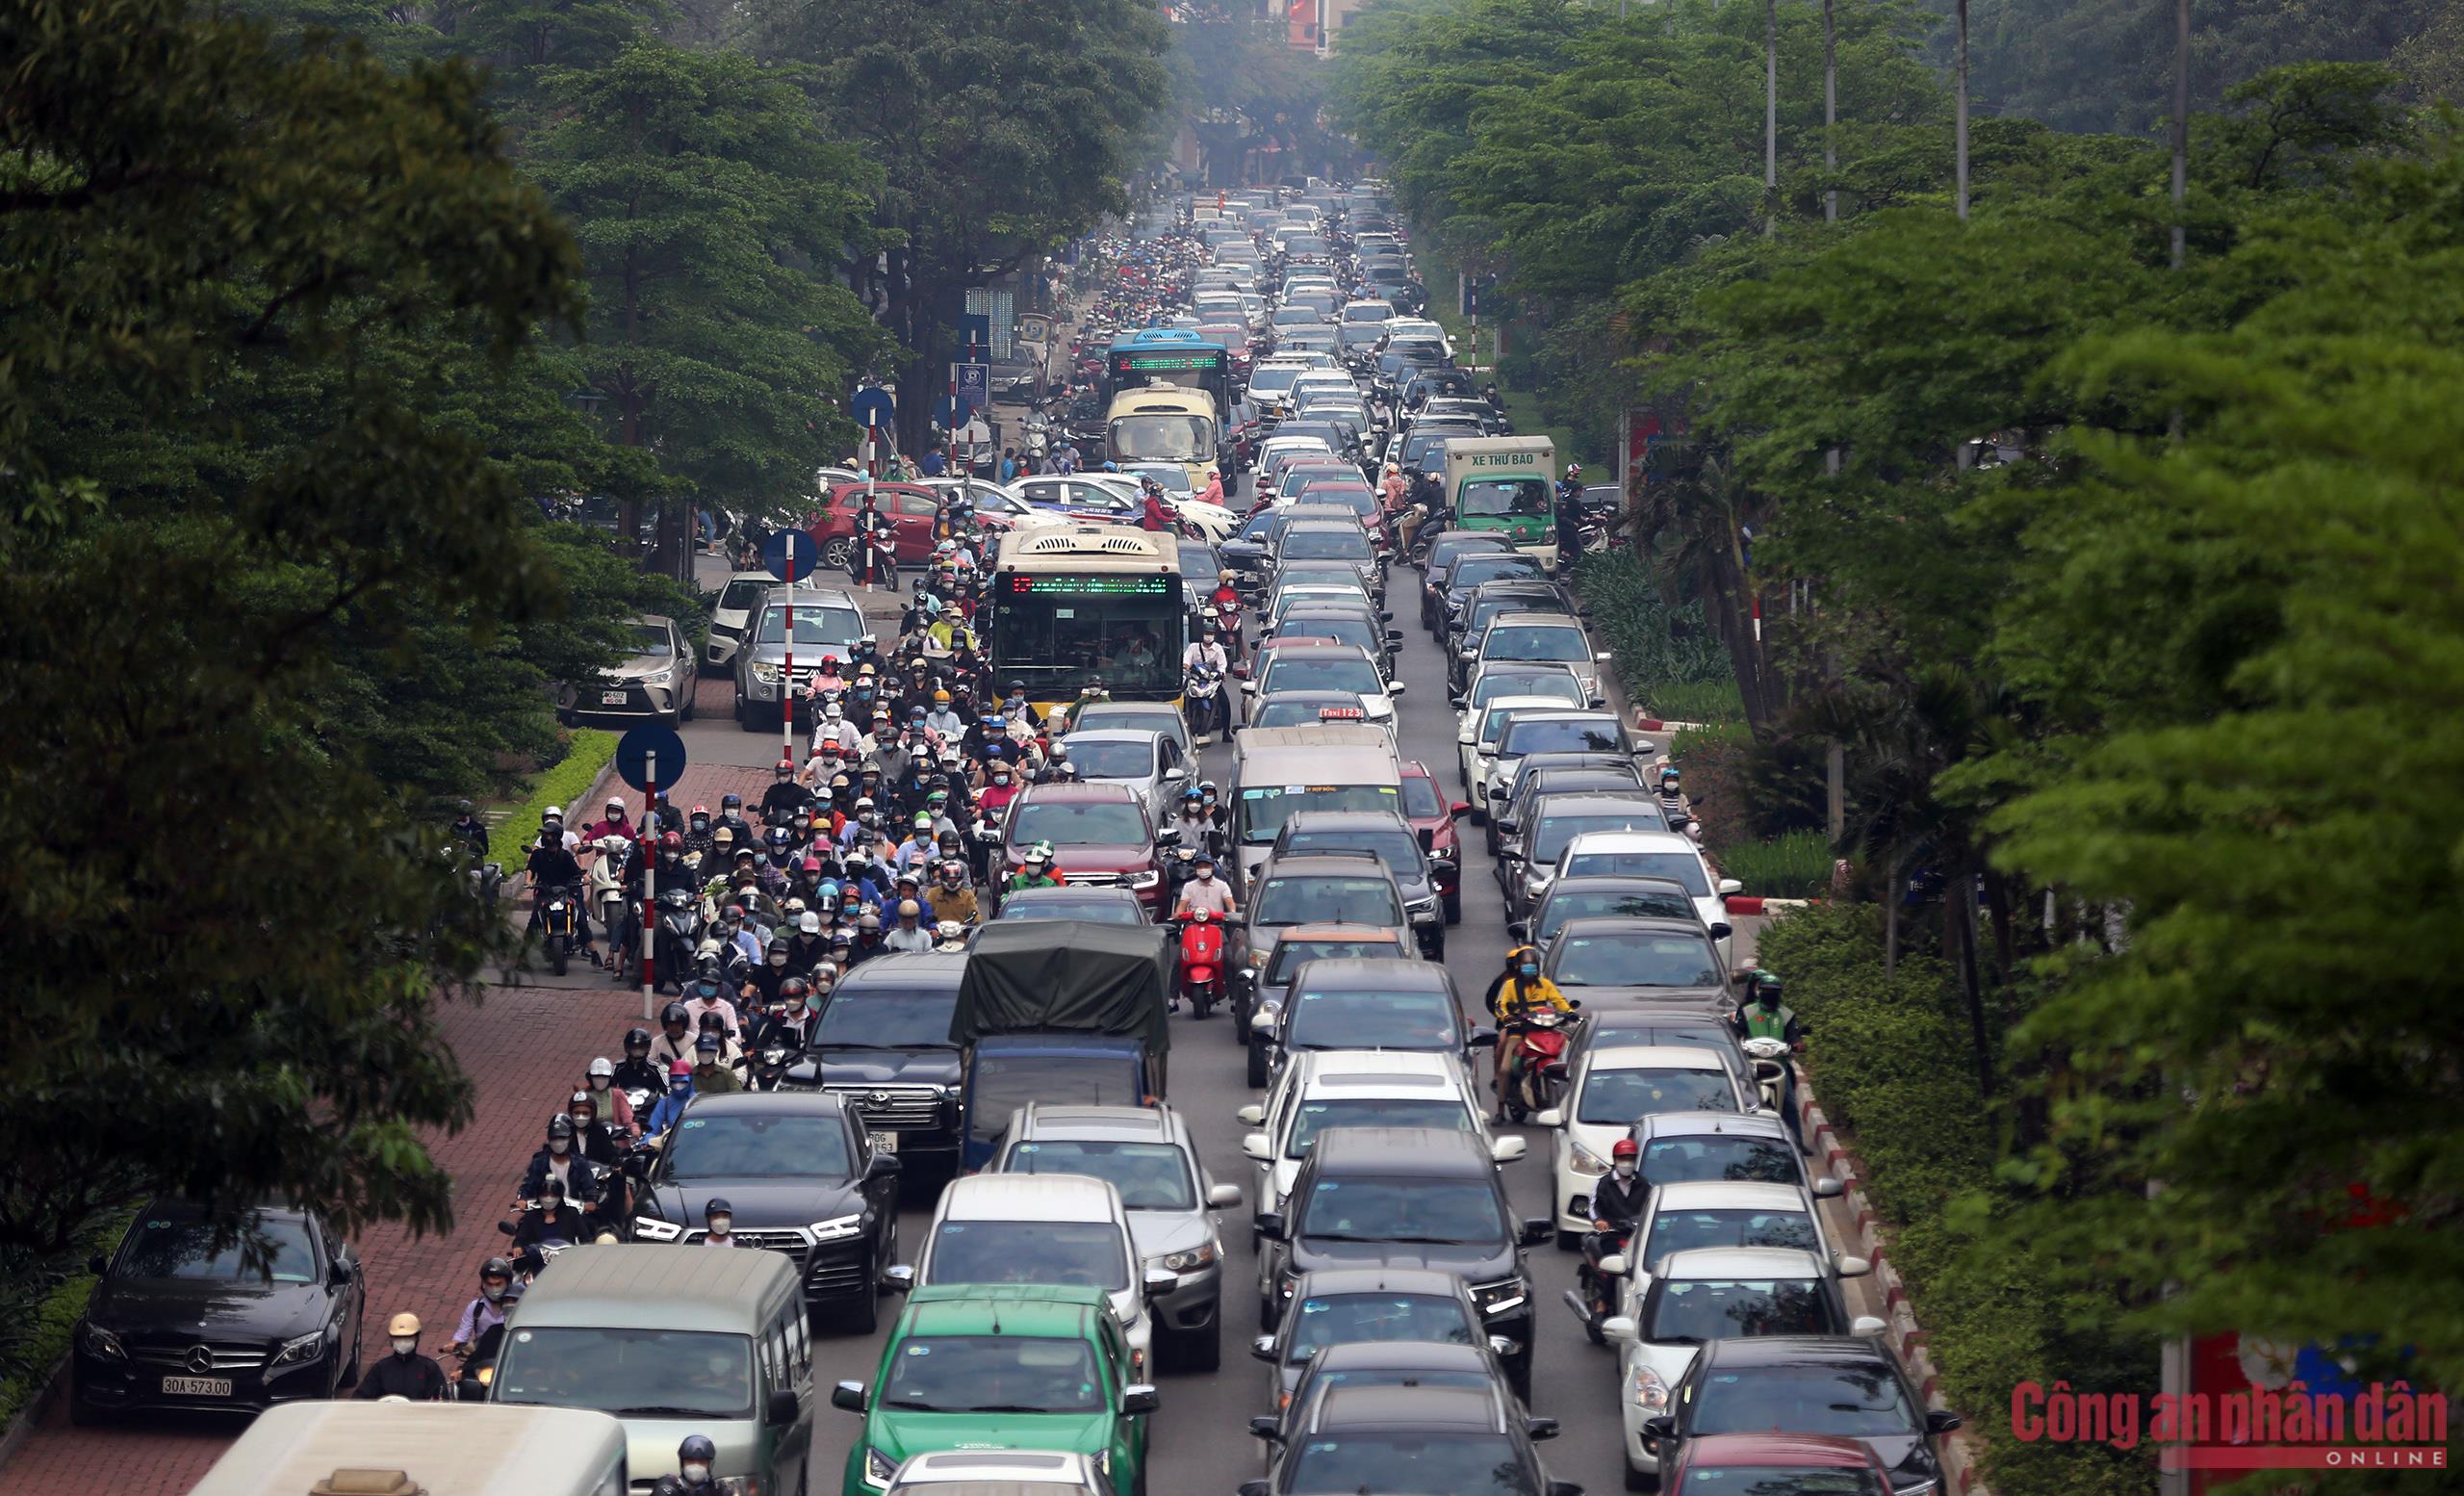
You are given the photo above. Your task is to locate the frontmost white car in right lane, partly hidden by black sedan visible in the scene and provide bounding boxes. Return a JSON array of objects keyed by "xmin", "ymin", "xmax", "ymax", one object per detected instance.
[{"xmin": 1599, "ymin": 1247, "xmax": 1890, "ymax": 1486}]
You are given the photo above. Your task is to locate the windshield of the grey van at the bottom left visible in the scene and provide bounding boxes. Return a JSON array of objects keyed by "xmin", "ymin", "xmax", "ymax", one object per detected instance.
[{"xmin": 488, "ymin": 1326, "xmax": 754, "ymax": 1420}]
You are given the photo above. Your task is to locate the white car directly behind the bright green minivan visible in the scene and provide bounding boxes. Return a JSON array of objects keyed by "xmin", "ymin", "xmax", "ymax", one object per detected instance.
[{"xmin": 882, "ymin": 1174, "xmax": 1180, "ymax": 1382}]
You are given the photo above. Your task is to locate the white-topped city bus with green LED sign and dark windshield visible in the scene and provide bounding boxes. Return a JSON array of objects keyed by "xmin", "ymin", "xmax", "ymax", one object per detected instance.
[{"xmin": 995, "ymin": 523, "xmax": 1188, "ymax": 712}]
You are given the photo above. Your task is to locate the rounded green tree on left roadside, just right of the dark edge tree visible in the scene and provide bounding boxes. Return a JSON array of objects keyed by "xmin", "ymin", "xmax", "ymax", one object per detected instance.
[{"xmin": 525, "ymin": 42, "xmax": 880, "ymax": 577}]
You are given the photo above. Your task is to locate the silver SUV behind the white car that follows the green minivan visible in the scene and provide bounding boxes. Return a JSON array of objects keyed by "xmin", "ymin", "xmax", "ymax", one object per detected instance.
[{"xmin": 993, "ymin": 1101, "xmax": 1242, "ymax": 1370}]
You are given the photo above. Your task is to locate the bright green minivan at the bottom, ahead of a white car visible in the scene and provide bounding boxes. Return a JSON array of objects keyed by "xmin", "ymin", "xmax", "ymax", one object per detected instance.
[{"xmin": 831, "ymin": 1284, "xmax": 1156, "ymax": 1496}]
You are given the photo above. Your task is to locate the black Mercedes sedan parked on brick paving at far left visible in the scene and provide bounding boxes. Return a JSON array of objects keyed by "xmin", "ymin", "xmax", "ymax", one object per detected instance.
[{"xmin": 69, "ymin": 1200, "xmax": 365, "ymax": 1422}]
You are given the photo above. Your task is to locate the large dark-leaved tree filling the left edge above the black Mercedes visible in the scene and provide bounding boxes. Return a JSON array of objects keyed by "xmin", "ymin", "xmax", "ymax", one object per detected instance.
[{"xmin": 0, "ymin": 0, "xmax": 579, "ymax": 1269}]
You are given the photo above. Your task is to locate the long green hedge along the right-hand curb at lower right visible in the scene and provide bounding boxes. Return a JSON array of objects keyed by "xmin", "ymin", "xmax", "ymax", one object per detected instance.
[{"xmin": 1755, "ymin": 905, "xmax": 2159, "ymax": 1496}]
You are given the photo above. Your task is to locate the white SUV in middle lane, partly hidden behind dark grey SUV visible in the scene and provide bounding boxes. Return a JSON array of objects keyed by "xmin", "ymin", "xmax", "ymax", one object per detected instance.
[{"xmin": 1235, "ymin": 1050, "xmax": 1530, "ymax": 1261}]
